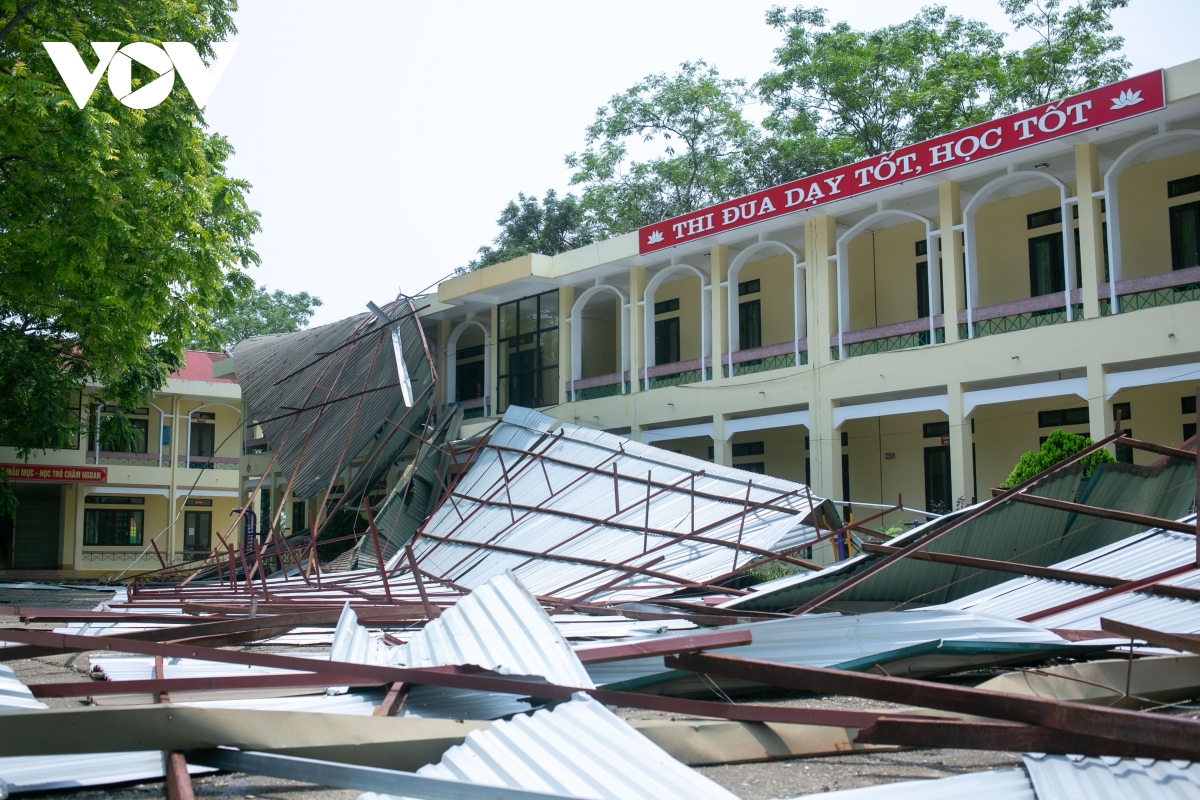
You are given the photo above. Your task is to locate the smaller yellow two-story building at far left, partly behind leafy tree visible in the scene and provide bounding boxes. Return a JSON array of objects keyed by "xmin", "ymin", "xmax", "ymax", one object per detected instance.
[{"xmin": 0, "ymin": 350, "xmax": 244, "ymax": 579}]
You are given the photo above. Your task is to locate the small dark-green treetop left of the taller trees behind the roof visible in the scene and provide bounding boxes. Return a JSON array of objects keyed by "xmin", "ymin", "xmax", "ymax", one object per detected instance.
[{"xmin": 460, "ymin": 190, "xmax": 595, "ymax": 275}]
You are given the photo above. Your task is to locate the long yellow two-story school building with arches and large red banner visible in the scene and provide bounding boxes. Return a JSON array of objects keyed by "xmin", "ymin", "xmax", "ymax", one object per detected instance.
[{"xmin": 422, "ymin": 61, "xmax": 1200, "ymax": 532}]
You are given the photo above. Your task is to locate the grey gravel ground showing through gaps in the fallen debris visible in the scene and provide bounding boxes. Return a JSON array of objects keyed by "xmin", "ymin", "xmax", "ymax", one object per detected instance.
[{"xmin": 0, "ymin": 589, "xmax": 1020, "ymax": 800}]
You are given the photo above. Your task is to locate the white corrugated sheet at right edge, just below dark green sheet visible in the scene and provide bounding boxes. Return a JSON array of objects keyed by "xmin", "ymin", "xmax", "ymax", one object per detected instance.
[{"xmin": 943, "ymin": 515, "xmax": 1200, "ymax": 633}]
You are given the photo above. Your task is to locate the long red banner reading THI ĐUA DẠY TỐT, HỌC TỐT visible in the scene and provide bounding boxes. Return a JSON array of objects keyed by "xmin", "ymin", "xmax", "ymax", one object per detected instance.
[{"xmin": 637, "ymin": 70, "xmax": 1166, "ymax": 253}]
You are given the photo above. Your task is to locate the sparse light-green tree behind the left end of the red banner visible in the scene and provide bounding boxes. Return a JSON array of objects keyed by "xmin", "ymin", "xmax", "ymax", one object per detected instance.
[{"xmin": 566, "ymin": 61, "xmax": 763, "ymax": 236}]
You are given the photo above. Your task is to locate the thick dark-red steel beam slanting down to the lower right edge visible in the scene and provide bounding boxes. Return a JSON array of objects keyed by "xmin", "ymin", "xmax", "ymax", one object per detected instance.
[{"xmin": 665, "ymin": 654, "xmax": 1200, "ymax": 753}]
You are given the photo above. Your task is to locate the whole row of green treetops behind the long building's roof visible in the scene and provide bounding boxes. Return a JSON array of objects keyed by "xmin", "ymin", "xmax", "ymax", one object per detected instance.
[{"xmin": 464, "ymin": 0, "xmax": 1129, "ymax": 269}]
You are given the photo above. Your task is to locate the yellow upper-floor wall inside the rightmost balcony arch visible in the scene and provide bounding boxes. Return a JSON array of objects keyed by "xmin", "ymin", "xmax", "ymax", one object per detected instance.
[{"xmin": 1117, "ymin": 151, "xmax": 1200, "ymax": 278}]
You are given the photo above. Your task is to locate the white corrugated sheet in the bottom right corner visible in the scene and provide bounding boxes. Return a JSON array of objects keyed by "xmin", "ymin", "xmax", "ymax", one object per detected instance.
[{"xmin": 1025, "ymin": 754, "xmax": 1200, "ymax": 800}]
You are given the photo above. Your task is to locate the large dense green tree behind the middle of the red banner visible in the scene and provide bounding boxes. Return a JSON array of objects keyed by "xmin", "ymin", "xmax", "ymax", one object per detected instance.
[{"xmin": 757, "ymin": 6, "xmax": 1004, "ymax": 160}]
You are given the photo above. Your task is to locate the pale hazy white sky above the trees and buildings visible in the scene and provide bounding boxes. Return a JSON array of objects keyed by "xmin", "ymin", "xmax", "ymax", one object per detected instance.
[{"xmin": 205, "ymin": 0, "xmax": 1200, "ymax": 324}]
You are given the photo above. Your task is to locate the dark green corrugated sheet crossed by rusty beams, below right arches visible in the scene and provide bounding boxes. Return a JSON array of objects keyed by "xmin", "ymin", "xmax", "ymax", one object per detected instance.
[{"xmin": 725, "ymin": 461, "xmax": 1195, "ymax": 610}]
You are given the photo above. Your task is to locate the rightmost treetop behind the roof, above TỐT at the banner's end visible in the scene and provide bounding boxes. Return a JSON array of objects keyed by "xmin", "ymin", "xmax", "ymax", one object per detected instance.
[{"xmin": 1001, "ymin": 0, "xmax": 1129, "ymax": 108}]
